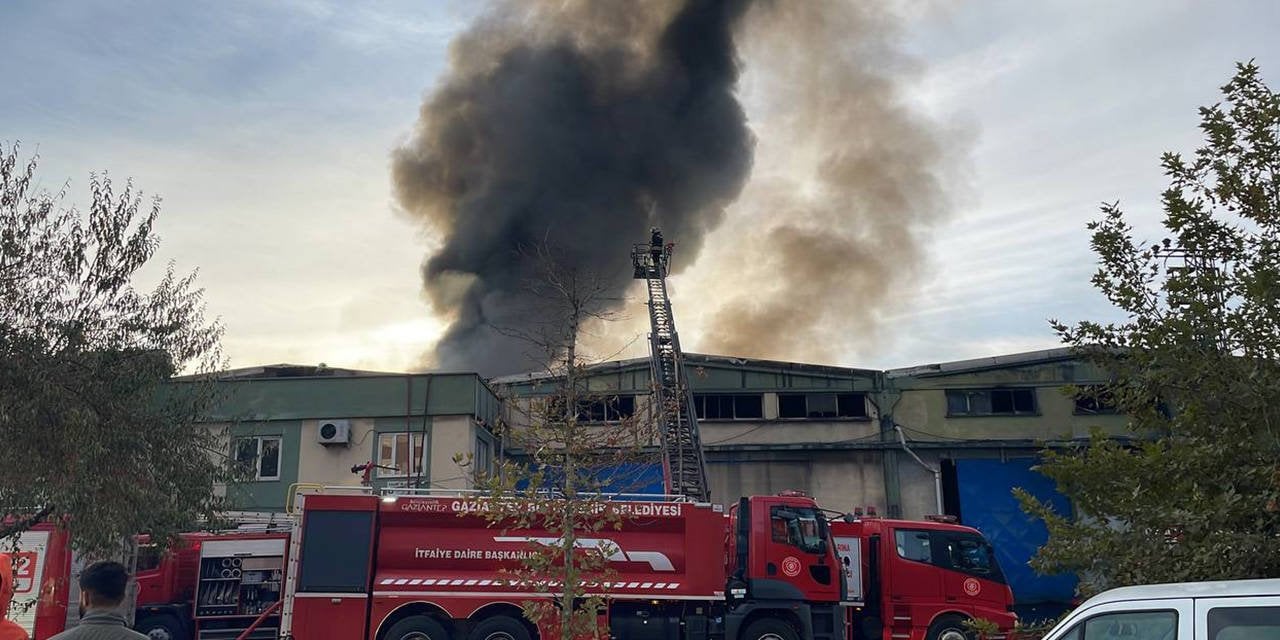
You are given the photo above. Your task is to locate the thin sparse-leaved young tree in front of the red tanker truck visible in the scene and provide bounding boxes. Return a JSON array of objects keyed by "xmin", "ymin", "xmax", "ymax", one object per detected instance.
[{"xmin": 458, "ymin": 244, "xmax": 655, "ymax": 640}]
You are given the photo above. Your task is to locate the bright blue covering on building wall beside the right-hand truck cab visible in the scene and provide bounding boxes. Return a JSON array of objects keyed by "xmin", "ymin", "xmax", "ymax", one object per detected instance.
[{"xmin": 956, "ymin": 458, "xmax": 1075, "ymax": 605}]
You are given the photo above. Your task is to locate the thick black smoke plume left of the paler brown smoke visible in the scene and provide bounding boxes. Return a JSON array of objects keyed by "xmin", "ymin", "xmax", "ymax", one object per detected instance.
[{"xmin": 392, "ymin": 0, "xmax": 754, "ymax": 375}]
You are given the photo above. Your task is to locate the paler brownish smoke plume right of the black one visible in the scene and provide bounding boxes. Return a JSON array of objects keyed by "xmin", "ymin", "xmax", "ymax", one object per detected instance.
[{"xmin": 696, "ymin": 0, "xmax": 966, "ymax": 364}]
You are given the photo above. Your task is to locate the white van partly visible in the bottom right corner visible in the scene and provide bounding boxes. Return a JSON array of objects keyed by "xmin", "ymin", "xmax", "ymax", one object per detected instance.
[{"xmin": 1044, "ymin": 580, "xmax": 1280, "ymax": 640}]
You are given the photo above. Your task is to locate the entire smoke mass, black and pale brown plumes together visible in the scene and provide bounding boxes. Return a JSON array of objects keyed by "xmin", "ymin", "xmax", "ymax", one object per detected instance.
[{"xmin": 392, "ymin": 0, "xmax": 965, "ymax": 375}]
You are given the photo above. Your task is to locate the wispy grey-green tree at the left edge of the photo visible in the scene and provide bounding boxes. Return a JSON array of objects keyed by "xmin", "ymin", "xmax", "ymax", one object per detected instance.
[{"xmin": 0, "ymin": 145, "xmax": 230, "ymax": 553}]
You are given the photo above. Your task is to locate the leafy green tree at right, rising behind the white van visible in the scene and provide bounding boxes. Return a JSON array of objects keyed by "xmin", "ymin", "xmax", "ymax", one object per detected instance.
[{"xmin": 1020, "ymin": 63, "xmax": 1280, "ymax": 594}]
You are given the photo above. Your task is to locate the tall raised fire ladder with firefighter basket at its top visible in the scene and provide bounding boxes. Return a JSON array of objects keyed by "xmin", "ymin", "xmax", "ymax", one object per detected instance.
[{"xmin": 631, "ymin": 230, "xmax": 710, "ymax": 502}]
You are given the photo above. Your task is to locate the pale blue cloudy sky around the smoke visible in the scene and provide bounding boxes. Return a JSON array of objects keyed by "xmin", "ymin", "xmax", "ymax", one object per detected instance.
[{"xmin": 0, "ymin": 0, "xmax": 1280, "ymax": 371}]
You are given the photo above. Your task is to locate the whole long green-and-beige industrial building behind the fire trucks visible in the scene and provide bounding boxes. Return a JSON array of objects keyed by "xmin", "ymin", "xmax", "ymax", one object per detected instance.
[{"xmin": 197, "ymin": 349, "xmax": 1125, "ymax": 614}]
